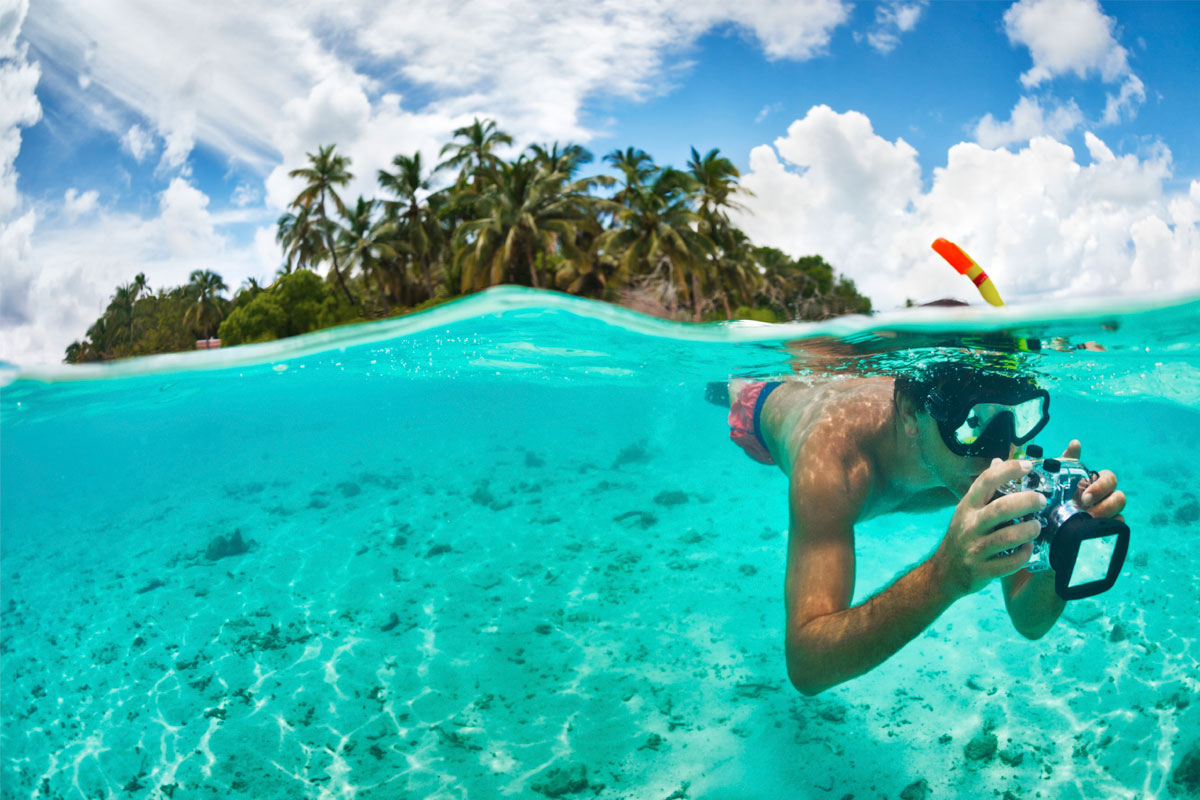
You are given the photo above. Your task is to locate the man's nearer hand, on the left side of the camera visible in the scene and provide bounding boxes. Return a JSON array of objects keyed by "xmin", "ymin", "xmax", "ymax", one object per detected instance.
[{"xmin": 931, "ymin": 455, "xmax": 1046, "ymax": 600}]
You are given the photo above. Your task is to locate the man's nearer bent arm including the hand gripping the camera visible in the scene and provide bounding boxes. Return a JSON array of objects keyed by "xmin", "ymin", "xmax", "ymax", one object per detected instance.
[{"xmin": 785, "ymin": 459, "xmax": 1044, "ymax": 696}]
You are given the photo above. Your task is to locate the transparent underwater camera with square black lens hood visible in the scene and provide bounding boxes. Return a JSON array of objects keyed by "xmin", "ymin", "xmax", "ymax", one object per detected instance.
[{"xmin": 997, "ymin": 445, "xmax": 1129, "ymax": 600}]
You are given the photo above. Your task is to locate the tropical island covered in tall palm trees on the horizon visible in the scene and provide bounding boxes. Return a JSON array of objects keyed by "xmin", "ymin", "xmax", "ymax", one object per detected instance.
[{"xmin": 66, "ymin": 119, "xmax": 871, "ymax": 363}]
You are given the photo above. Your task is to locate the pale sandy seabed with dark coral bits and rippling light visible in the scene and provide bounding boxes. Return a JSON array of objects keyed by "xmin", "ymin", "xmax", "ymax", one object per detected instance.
[{"xmin": 0, "ymin": 388, "xmax": 1200, "ymax": 800}]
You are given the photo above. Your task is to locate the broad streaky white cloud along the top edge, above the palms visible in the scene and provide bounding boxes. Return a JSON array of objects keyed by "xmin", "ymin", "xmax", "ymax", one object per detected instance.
[{"xmin": 25, "ymin": 0, "xmax": 848, "ymax": 173}]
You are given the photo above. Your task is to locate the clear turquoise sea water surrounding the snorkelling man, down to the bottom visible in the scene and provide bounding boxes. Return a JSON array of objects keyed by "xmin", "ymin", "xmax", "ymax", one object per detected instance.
[{"xmin": 0, "ymin": 289, "xmax": 1200, "ymax": 800}]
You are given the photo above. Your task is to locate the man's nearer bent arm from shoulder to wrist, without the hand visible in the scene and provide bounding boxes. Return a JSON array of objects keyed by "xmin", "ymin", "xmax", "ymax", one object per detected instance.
[{"xmin": 785, "ymin": 462, "xmax": 954, "ymax": 696}]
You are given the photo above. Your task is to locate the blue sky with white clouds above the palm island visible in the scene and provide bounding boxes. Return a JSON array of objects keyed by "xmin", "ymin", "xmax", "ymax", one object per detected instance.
[{"xmin": 0, "ymin": 0, "xmax": 1200, "ymax": 363}]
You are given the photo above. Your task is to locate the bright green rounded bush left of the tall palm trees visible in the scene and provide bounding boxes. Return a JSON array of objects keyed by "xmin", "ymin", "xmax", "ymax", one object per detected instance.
[{"xmin": 220, "ymin": 270, "xmax": 359, "ymax": 345}]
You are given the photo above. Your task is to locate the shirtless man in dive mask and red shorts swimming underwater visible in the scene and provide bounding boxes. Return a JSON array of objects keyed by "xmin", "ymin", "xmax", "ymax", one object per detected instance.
[{"xmin": 728, "ymin": 365, "xmax": 1126, "ymax": 696}]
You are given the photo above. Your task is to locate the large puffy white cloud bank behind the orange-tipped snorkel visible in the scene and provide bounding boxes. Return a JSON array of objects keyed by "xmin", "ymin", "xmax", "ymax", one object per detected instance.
[{"xmin": 736, "ymin": 106, "xmax": 1200, "ymax": 308}]
